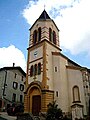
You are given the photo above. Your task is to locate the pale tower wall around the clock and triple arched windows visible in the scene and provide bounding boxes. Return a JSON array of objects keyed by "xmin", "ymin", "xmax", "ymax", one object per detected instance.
[{"xmin": 28, "ymin": 46, "xmax": 43, "ymax": 84}]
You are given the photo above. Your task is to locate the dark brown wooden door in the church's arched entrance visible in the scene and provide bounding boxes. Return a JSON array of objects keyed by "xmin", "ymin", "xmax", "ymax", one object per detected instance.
[{"xmin": 32, "ymin": 95, "xmax": 41, "ymax": 116}]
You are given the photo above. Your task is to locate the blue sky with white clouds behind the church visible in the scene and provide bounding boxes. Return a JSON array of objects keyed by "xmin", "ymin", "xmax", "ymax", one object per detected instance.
[{"xmin": 0, "ymin": 0, "xmax": 90, "ymax": 72}]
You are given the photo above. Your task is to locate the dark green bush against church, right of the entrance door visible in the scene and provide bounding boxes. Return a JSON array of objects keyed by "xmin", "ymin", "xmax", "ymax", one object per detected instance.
[{"xmin": 46, "ymin": 101, "xmax": 63, "ymax": 120}]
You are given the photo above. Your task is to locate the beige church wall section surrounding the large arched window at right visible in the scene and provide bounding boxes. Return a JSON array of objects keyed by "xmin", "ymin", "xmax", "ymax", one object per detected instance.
[{"xmin": 67, "ymin": 68, "xmax": 87, "ymax": 115}]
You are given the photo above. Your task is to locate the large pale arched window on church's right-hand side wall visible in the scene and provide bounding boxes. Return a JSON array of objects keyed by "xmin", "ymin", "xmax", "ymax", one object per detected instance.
[{"xmin": 73, "ymin": 86, "xmax": 80, "ymax": 102}]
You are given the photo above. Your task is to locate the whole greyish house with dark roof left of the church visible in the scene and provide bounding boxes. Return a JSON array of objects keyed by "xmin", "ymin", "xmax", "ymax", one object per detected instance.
[{"xmin": 0, "ymin": 66, "xmax": 26, "ymax": 110}]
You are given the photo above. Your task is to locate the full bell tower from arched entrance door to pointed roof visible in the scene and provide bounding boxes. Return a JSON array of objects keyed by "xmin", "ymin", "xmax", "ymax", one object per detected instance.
[{"xmin": 24, "ymin": 10, "xmax": 61, "ymax": 115}]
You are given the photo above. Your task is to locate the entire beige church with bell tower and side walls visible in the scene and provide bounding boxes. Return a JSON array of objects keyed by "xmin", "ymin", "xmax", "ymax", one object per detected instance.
[{"xmin": 24, "ymin": 10, "xmax": 90, "ymax": 120}]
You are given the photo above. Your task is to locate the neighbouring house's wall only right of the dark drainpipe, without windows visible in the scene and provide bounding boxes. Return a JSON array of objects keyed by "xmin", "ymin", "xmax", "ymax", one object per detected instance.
[{"xmin": 5, "ymin": 70, "xmax": 25, "ymax": 102}]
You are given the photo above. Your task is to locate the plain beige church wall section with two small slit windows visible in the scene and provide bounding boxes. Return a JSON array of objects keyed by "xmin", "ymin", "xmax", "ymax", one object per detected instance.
[{"xmin": 53, "ymin": 55, "xmax": 69, "ymax": 112}]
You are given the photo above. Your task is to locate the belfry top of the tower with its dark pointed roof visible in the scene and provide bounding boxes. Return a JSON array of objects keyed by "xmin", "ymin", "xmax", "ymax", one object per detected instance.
[{"xmin": 29, "ymin": 10, "xmax": 59, "ymax": 47}]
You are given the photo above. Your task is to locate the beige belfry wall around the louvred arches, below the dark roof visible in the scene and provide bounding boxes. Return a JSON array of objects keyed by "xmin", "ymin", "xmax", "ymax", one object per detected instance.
[{"xmin": 29, "ymin": 20, "xmax": 60, "ymax": 47}]
